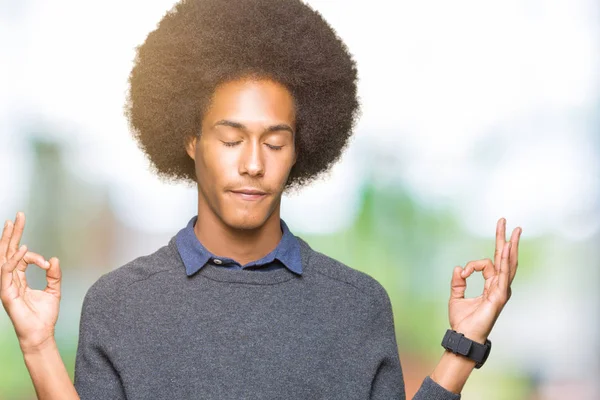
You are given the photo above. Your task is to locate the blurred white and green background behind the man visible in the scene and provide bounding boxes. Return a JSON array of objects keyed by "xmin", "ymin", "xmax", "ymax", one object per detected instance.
[{"xmin": 0, "ymin": 0, "xmax": 600, "ymax": 400}]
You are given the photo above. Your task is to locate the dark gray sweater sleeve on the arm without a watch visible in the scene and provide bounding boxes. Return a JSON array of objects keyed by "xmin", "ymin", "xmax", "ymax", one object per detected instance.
[{"xmin": 75, "ymin": 277, "xmax": 126, "ymax": 400}]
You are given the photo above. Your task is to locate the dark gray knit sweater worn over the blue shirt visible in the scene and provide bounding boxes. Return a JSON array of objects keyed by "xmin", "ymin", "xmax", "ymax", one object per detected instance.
[{"xmin": 75, "ymin": 237, "xmax": 460, "ymax": 400}]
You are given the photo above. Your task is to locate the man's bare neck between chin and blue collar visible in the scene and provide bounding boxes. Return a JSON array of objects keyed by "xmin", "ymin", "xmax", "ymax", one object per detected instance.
[{"xmin": 194, "ymin": 194, "xmax": 282, "ymax": 265}]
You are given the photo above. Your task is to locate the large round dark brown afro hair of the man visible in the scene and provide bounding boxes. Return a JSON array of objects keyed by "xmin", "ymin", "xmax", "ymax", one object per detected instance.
[{"xmin": 125, "ymin": 0, "xmax": 360, "ymax": 188}]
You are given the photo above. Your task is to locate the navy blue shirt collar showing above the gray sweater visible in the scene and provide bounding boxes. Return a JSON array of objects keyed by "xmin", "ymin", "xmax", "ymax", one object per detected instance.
[{"xmin": 175, "ymin": 215, "xmax": 302, "ymax": 276}]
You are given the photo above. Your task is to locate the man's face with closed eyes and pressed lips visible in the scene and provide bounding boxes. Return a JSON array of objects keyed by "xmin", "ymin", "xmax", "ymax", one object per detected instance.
[{"xmin": 187, "ymin": 79, "xmax": 296, "ymax": 229}]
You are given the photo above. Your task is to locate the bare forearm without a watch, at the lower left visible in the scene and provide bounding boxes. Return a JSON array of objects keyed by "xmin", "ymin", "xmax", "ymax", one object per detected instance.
[{"xmin": 23, "ymin": 340, "xmax": 79, "ymax": 400}]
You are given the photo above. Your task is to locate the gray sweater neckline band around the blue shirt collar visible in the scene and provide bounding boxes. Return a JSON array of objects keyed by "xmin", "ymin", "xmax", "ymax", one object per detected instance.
[{"xmin": 168, "ymin": 236, "xmax": 313, "ymax": 285}]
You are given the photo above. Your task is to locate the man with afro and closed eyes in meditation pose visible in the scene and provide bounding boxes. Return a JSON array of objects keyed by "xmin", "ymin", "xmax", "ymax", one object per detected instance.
[{"xmin": 0, "ymin": 0, "xmax": 521, "ymax": 399}]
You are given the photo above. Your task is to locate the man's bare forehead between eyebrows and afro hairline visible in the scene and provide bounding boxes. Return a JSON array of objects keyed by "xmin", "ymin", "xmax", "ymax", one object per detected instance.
[{"xmin": 205, "ymin": 78, "xmax": 295, "ymax": 123}]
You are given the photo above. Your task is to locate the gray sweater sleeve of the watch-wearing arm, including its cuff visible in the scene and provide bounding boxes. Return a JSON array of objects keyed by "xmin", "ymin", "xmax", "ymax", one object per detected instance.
[{"xmin": 370, "ymin": 285, "xmax": 461, "ymax": 400}]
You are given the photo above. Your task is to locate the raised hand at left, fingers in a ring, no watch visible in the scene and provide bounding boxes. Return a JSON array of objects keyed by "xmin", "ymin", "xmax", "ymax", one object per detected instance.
[{"xmin": 0, "ymin": 212, "xmax": 61, "ymax": 352}]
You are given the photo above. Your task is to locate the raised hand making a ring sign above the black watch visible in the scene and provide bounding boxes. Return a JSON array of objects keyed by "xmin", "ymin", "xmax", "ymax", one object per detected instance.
[{"xmin": 448, "ymin": 218, "xmax": 522, "ymax": 343}]
